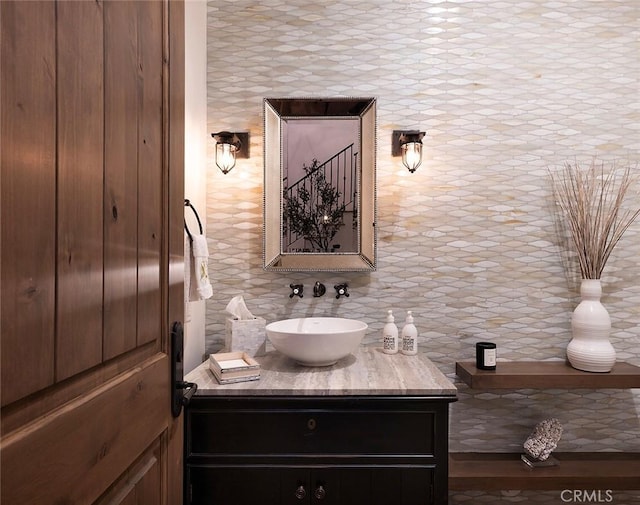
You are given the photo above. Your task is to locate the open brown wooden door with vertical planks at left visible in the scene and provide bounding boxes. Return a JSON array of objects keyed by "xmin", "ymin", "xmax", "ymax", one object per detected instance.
[{"xmin": 0, "ymin": 0, "xmax": 184, "ymax": 505}]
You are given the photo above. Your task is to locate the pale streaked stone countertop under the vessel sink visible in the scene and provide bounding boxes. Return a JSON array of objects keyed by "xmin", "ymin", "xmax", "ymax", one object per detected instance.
[{"xmin": 184, "ymin": 346, "xmax": 457, "ymax": 396}]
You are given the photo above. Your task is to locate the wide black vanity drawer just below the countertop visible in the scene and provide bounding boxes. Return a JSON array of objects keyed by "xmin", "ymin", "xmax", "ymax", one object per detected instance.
[{"xmin": 187, "ymin": 409, "xmax": 436, "ymax": 456}]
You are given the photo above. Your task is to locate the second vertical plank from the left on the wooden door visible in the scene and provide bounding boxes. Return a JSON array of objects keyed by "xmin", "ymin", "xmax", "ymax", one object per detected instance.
[{"xmin": 56, "ymin": 2, "xmax": 104, "ymax": 380}]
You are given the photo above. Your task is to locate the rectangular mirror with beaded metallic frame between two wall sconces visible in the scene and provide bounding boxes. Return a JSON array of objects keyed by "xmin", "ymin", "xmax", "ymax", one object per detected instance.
[{"xmin": 264, "ymin": 97, "xmax": 377, "ymax": 272}]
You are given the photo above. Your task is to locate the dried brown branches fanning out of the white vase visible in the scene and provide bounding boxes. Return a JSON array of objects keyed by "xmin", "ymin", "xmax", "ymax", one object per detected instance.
[{"xmin": 550, "ymin": 161, "xmax": 640, "ymax": 279}]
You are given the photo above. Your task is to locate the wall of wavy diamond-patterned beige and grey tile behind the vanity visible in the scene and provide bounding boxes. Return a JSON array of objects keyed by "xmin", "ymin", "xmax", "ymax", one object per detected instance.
[{"xmin": 206, "ymin": 0, "xmax": 640, "ymax": 503}]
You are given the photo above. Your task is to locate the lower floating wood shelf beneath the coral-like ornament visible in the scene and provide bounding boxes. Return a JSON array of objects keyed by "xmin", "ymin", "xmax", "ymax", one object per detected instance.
[{"xmin": 449, "ymin": 452, "xmax": 640, "ymax": 491}]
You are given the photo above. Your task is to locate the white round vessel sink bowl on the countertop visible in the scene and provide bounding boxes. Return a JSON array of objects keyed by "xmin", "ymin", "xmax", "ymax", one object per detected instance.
[{"xmin": 265, "ymin": 317, "xmax": 367, "ymax": 366}]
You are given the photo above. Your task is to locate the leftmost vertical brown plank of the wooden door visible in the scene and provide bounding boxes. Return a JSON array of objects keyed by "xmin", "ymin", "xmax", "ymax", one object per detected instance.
[{"xmin": 0, "ymin": 1, "xmax": 56, "ymax": 406}]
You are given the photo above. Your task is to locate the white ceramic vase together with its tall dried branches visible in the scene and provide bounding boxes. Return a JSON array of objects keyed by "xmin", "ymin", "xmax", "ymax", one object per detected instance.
[{"xmin": 551, "ymin": 160, "xmax": 640, "ymax": 372}]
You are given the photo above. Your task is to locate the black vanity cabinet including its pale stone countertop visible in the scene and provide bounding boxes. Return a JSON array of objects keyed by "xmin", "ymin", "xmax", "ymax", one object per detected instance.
[{"xmin": 185, "ymin": 348, "xmax": 456, "ymax": 505}]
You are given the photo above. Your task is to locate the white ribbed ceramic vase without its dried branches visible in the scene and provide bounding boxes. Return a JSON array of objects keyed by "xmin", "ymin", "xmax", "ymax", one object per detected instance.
[{"xmin": 567, "ymin": 279, "xmax": 616, "ymax": 372}]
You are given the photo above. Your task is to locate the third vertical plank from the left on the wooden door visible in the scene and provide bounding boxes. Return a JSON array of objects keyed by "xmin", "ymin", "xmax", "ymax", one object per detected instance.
[{"xmin": 103, "ymin": 1, "xmax": 142, "ymax": 359}]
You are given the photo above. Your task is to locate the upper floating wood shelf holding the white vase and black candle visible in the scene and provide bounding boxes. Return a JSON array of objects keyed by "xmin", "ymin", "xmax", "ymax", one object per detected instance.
[{"xmin": 456, "ymin": 361, "xmax": 640, "ymax": 389}]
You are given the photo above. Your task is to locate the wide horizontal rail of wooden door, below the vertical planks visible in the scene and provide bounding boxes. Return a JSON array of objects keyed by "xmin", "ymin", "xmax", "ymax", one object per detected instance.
[{"xmin": 2, "ymin": 354, "xmax": 169, "ymax": 505}]
